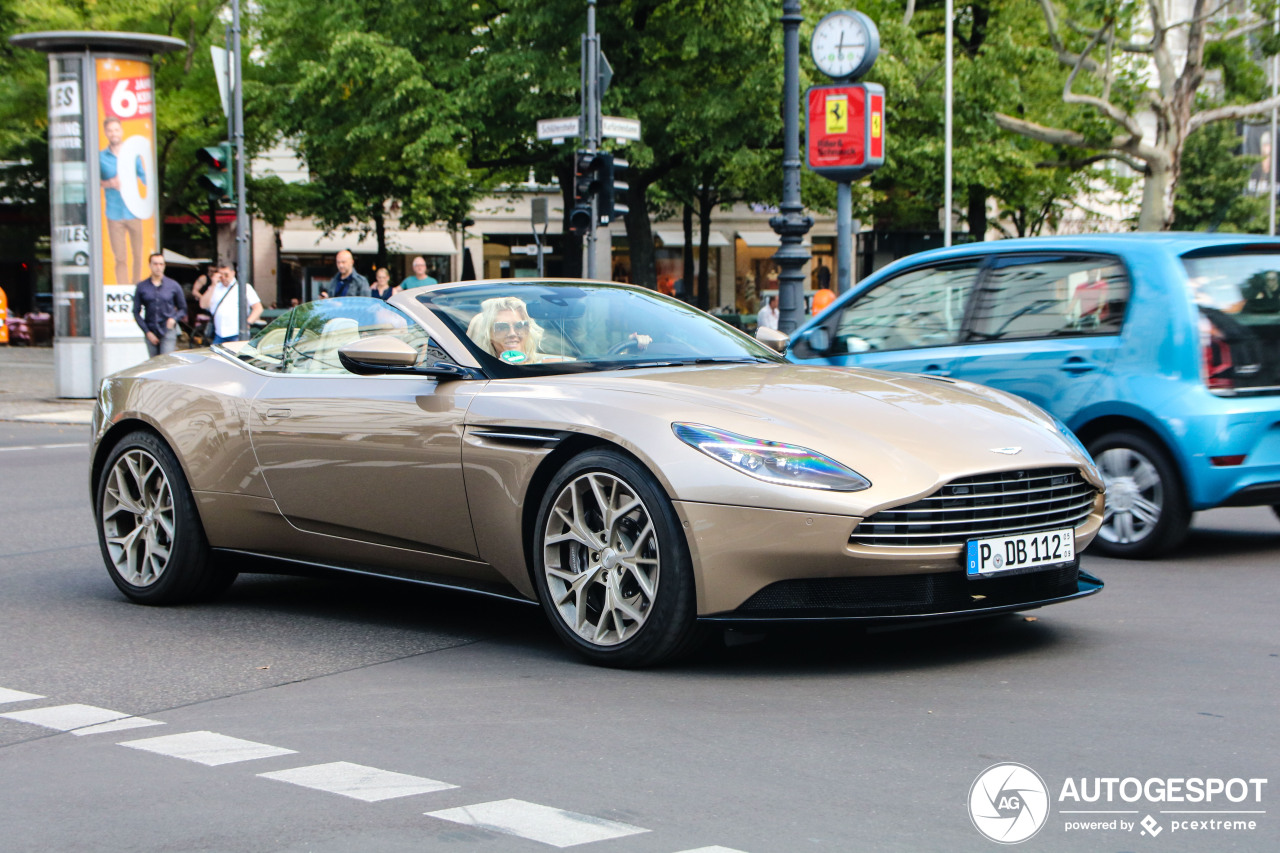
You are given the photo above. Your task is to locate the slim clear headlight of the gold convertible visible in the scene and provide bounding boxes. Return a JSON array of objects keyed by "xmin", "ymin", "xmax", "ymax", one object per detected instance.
[{"xmin": 671, "ymin": 424, "xmax": 870, "ymax": 492}]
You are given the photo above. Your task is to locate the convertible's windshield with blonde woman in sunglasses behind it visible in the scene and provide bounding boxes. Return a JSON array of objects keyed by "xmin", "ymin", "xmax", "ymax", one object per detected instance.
[{"xmin": 419, "ymin": 280, "xmax": 783, "ymax": 377}]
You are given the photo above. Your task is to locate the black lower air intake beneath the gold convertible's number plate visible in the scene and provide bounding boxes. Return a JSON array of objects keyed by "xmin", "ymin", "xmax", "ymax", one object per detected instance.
[{"xmin": 737, "ymin": 565, "xmax": 1080, "ymax": 617}]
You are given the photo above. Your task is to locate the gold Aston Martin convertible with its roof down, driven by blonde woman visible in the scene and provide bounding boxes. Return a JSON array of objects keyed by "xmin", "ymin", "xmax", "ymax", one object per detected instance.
[{"xmin": 91, "ymin": 279, "xmax": 1103, "ymax": 666}]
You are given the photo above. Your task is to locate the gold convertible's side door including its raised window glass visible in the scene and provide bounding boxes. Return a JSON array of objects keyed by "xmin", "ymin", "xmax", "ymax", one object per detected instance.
[{"xmin": 250, "ymin": 297, "xmax": 479, "ymax": 558}]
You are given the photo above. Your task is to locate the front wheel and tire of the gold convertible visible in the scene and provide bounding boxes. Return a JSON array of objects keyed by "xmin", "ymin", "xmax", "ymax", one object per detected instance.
[{"xmin": 532, "ymin": 450, "xmax": 701, "ymax": 667}]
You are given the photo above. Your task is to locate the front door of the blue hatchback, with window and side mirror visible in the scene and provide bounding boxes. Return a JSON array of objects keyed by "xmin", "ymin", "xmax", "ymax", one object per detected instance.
[{"xmin": 794, "ymin": 259, "xmax": 982, "ymax": 377}]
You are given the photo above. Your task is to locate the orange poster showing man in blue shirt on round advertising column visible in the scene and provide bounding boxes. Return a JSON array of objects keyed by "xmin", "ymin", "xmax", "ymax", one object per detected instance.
[{"xmin": 96, "ymin": 59, "xmax": 160, "ymax": 338}]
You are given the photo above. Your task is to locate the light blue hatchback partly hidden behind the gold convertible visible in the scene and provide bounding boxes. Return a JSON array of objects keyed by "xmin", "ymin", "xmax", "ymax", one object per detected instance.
[{"xmin": 788, "ymin": 233, "xmax": 1280, "ymax": 557}]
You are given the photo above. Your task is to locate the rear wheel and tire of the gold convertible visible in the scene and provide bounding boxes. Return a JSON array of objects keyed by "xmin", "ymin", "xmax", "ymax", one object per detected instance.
[{"xmin": 93, "ymin": 430, "xmax": 236, "ymax": 605}]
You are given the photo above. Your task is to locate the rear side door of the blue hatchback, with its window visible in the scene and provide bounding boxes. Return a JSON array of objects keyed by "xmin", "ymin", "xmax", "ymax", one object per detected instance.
[{"xmin": 952, "ymin": 252, "xmax": 1129, "ymax": 423}]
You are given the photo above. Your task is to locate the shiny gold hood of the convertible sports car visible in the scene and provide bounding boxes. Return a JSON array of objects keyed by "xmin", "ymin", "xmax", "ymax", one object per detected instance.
[{"xmin": 527, "ymin": 364, "xmax": 1102, "ymax": 497}]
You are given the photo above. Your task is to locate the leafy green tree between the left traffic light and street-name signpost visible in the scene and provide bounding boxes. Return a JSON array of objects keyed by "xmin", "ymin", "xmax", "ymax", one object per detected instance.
[{"xmin": 256, "ymin": 0, "xmax": 485, "ymax": 265}]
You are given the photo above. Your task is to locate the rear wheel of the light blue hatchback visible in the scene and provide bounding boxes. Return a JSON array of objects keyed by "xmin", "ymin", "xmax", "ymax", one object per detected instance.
[{"xmin": 1089, "ymin": 430, "xmax": 1192, "ymax": 560}]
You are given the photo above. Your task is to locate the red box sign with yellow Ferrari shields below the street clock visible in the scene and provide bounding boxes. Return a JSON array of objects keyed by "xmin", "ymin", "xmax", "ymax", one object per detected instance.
[{"xmin": 808, "ymin": 83, "xmax": 884, "ymax": 181}]
